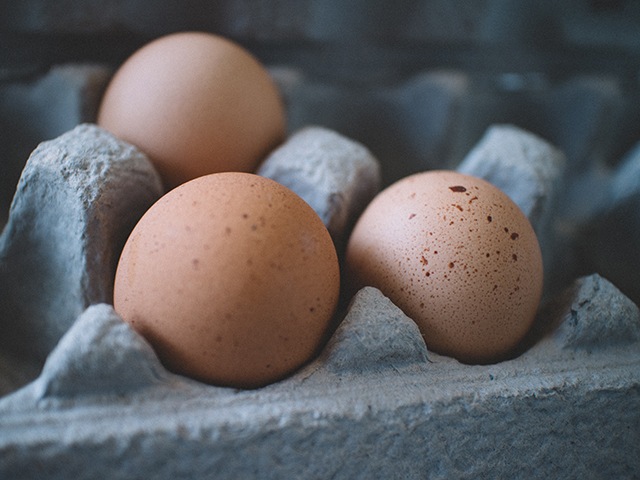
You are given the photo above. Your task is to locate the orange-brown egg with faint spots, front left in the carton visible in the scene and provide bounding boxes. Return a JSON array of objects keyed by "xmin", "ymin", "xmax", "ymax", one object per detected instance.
[{"xmin": 114, "ymin": 173, "xmax": 340, "ymax": 388}]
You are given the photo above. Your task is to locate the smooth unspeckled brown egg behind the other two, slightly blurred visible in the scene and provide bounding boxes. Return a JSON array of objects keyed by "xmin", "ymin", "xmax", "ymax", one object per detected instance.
[{"xmin": 97, "ymin": 32, "xmax": 285, "ymax": 188}]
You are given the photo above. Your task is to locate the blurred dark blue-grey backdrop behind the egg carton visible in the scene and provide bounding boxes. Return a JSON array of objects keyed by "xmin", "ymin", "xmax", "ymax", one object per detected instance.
[{"xmin": 0, "ymin": 0, "xmax": 640, "ymax": 82}]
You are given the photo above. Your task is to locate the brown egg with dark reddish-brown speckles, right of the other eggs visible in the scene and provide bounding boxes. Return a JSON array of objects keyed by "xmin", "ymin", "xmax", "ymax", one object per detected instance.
[{"xmin": 346, "ymin": 171, "xmax": 542, "ymax": 363}]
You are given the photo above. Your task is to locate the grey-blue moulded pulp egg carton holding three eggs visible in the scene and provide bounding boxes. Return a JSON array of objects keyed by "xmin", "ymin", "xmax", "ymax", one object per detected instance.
[{"xmin": 0, "ymin": 61, "xmax": 640, "ymax": 478}]
